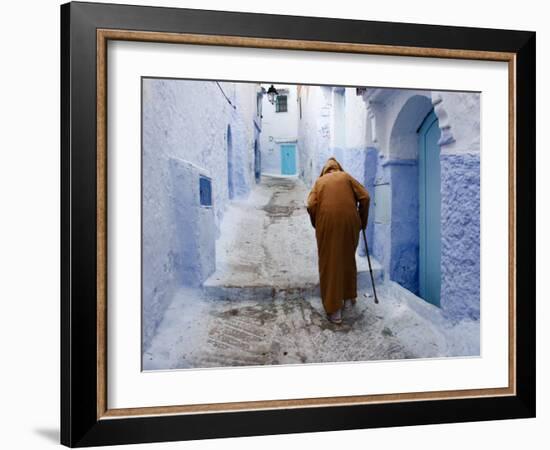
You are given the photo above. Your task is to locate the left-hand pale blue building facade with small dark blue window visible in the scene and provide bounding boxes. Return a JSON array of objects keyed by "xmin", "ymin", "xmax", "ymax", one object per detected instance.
[{"xmin": 142, "ymin": 78, "xmax": 262, "ymax": 346}]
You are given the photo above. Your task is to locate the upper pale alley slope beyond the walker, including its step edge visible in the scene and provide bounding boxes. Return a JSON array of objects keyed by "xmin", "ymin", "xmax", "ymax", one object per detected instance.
[{"xmin": 203, "ymin": 176, "xmax": 381, "ymax": 300}]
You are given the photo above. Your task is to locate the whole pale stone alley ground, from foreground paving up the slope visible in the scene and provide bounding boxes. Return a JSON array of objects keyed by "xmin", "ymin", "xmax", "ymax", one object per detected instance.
[{"xmin": 143, "ymin": 175, "xmax": 479, "ymax": 370}]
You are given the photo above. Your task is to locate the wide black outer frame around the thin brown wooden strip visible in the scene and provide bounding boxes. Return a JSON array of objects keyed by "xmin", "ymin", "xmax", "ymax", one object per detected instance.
[{"xmin": 61, "ymin": 2, "xmax": 536, "ymax": 447}]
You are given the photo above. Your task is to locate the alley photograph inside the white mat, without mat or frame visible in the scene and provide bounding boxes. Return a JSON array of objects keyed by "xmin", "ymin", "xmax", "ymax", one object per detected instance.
[{"xmin": 141, "ymin": 76, "xmax": 484, "ymax": 371}]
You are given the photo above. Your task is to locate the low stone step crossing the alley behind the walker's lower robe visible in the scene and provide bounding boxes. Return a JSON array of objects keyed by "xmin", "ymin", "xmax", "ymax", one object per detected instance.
[{"xmin": 203, "ymin": 256, "xmax": 384, "ymax": 300}]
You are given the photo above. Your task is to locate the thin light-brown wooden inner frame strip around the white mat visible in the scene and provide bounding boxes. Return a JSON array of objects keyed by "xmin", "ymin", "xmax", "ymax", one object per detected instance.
[{"xmin": 97, "ymin": 29, "xmax": 516, "ymax": 420}]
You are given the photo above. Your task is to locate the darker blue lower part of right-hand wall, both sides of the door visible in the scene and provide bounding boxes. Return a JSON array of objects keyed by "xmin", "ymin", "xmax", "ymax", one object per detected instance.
[{"xmin": 365, "ymin": 150, "xmax": 480, "ymax": 319}]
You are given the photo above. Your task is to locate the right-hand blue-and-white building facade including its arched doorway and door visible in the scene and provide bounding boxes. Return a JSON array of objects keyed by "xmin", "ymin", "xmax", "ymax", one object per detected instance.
[{"xmin": 298, "ymin": 86, "xmax": 480, "ymax": 320}]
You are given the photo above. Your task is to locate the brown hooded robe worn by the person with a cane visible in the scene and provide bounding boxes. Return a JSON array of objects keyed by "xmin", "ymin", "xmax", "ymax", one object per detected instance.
[{"xmin": 307, "ymin": 158, "xmax": 370, "ymax": 314}]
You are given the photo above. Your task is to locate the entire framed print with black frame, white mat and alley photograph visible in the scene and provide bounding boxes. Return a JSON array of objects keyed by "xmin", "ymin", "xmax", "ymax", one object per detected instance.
[{"xmin": 61, "ymin": 2, "xmax": 535, "ymax": 447}]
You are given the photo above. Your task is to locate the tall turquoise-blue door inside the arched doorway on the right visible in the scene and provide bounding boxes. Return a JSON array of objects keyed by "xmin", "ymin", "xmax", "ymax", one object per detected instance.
[{"xmin": 418, "ymin": 111, "xmax": 441, "ymax": 306}]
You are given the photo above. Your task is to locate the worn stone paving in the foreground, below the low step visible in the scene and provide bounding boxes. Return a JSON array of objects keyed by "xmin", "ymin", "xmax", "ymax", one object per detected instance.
[{"xmin": 144, "ymin": 291, "xmax": 416, "ymax": 369}]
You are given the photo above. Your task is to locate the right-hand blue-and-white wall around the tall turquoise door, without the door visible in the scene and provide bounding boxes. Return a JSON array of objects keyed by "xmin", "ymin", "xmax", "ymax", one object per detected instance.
[{"xmin": 298, "ymin": 87, "xmax": 480, "ymax": 318}]
